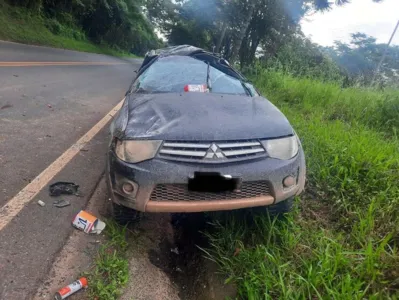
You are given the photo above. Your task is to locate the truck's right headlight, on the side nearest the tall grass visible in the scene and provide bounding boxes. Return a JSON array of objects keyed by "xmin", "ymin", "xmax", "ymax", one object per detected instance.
[{"xmin": 262, "ymin": 135, "xmax": 299, "ymax": 159}]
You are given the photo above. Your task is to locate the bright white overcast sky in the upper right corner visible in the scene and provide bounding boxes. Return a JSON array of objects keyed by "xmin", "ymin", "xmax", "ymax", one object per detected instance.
[{"xmin": 301, "ymin": 0, "xmax": 399, "ymax": 46}]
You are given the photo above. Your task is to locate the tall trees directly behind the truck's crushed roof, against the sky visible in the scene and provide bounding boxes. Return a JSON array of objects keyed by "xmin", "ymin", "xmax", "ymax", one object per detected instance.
[{"xmin": 146, "ymin": 0, "xmax": 380, "ymax": 66}]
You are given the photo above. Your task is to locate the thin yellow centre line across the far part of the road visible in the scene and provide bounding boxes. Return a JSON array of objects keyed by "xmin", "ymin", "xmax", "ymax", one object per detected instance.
[{"xmin": 0, "ymin": 61, "xmax": 127, "ymax": 67}]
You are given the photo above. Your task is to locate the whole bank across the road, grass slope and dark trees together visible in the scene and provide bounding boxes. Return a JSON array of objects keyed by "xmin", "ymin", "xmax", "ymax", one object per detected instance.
[{"xmin": 0, "ymin": 0, "xmax": 161, "ymax": 57}]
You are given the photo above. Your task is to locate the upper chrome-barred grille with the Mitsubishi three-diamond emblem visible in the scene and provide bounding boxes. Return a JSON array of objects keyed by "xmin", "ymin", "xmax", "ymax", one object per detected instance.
[{"xmin": 159, "ymin": 140, "xmax": 266, "ymax": 162}]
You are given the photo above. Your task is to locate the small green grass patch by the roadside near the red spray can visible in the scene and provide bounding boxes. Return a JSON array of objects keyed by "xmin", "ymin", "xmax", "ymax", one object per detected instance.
[{"xmin": 88, "ymin": 221, "xmax": 129, "ymax": 300}]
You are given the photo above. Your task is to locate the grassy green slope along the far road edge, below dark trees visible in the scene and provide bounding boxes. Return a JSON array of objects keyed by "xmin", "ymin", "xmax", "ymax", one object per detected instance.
[{"xmin": 0, "ymin": 0, "xmax": 136, "ymax": 57}]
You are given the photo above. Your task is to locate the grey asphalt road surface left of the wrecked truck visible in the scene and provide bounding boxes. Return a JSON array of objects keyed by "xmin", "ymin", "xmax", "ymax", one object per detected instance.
[{"xmin": 0, "ymin": 42, "xmax": 139, "ymax": 300}]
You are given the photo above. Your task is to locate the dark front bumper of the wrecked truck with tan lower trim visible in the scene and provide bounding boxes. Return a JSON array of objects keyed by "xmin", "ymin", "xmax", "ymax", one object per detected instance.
[{"xmin": 107, "ymin": 149, "xmax": 306, "ymax": 212}]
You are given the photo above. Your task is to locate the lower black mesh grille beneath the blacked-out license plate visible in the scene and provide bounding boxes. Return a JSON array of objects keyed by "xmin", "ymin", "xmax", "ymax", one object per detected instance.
[{"xmin": 150, "ymin": 181, "xmax": 270, "ymax": 201}]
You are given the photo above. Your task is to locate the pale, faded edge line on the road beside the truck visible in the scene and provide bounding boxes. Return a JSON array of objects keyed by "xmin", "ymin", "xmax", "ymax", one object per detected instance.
[{"xmin": 0, "ymin": 99, "xmax": 124, "ymax": 231}]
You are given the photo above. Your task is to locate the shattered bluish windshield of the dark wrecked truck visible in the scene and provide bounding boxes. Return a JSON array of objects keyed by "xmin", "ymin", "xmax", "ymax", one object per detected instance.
[{"xmin": 133, "ymin": 56, "xmax": 247, "ymax": 95}]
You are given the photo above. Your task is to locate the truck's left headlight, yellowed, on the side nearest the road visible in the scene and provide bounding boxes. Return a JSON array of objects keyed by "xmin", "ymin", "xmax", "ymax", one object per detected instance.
[{"xmin": 115, "ymin": 140, "xmax": 162, "ymax": 163}]
